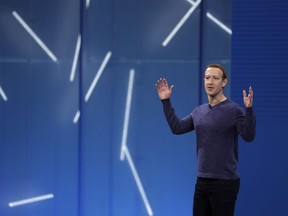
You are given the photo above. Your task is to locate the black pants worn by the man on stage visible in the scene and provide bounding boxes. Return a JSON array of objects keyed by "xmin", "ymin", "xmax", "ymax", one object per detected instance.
[{"xmin": 193, "ymin": 178, "xmax": 240, "ymax": 216}]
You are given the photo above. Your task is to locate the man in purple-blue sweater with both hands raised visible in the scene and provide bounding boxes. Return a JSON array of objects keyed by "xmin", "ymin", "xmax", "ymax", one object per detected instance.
[{"xmin": 156, "ymin": 64, "xmax": 256, "ymax": 216}]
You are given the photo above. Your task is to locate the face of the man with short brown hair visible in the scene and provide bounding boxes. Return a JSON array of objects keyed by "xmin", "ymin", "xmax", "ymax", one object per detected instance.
[{"xmin": 204, "ymin": 67, "xmax": 227, "ymax": 97}]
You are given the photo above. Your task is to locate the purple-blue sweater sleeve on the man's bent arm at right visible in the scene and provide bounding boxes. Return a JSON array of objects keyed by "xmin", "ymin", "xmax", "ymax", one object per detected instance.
[{"xmin": 236, "ymin": 108, "xmax": 256, "ymax": 142}]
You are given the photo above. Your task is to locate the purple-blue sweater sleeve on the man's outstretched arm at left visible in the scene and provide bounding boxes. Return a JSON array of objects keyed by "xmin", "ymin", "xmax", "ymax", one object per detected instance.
[{"xmin": 161, "ymin": 99, "xmax": 194, "ymax": 134}]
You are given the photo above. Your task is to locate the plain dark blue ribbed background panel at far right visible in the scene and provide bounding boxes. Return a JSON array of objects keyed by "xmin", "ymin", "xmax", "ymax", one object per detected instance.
[{"xmin": 231, "ymin": 0, "xmax": 288, "ymax": 216}]
